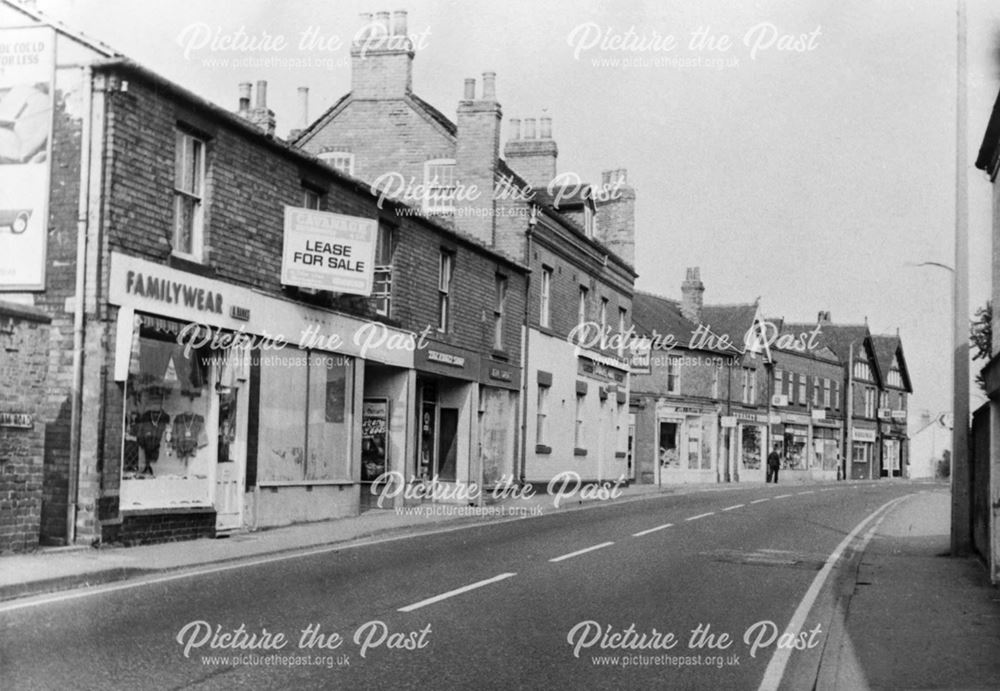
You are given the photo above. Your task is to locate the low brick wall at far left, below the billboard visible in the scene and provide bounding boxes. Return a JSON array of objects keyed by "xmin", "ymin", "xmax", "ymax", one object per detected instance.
[{"xmin": 0, "ymin": 302, "xmax": 49, "ymax": 552}]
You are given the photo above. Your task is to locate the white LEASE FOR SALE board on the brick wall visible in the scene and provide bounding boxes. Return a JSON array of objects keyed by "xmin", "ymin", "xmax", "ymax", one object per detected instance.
[{"xmin": 281, "ymin": 206, "xmax": 378, "ymax": 295}]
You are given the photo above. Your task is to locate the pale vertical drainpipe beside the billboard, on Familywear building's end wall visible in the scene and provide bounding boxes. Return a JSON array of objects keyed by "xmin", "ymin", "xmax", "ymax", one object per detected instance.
[{"xmin": 66, "ymin": 66, "xmax": 93, "ymax": 545}]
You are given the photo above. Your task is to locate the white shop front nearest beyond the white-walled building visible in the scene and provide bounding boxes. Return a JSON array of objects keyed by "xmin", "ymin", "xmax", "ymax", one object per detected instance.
[{"xmin": 656, "ymin": 402, "xmax": 718, "ymax": 485}]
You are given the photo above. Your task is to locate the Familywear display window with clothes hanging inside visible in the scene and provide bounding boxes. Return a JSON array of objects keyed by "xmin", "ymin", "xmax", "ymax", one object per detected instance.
[{"xmin": 121, "ymin": 327, "xmax": 215, "ymax": 509}]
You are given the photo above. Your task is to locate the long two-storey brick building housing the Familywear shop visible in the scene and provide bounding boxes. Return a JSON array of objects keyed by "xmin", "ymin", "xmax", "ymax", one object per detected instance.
[{"xmin": 0, "ymin": 3, "xmax": 527, "ymax": 543}]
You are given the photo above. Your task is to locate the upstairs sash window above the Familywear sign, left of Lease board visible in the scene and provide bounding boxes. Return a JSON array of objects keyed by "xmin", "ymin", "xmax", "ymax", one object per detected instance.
[{"xmin": 173, "ymin": 129, "xmax": 205, "ymax": 262}]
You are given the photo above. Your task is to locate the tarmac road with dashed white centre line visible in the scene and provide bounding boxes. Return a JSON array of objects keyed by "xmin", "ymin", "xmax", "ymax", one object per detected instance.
[{"xmin": 0, "ymin": 482, "xmax": 917, "ymax": 689}]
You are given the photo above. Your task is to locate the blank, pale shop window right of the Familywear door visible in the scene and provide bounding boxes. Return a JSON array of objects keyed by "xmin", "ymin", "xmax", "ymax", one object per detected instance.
[{"xmin": 257, "ymin": 347, "xmax": 354, "ymax": 484}]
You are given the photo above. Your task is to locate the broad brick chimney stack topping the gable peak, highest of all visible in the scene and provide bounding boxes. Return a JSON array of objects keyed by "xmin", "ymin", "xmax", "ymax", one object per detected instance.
[{"xmin": 351, "ymin": 12, "xmax": 413, "ymax": 100}]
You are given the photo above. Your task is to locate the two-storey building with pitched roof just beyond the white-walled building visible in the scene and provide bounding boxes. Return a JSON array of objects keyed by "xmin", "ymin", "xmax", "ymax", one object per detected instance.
[{"xmin": 630, "ymin": 267, "xmax": 770, "ymax": 484}]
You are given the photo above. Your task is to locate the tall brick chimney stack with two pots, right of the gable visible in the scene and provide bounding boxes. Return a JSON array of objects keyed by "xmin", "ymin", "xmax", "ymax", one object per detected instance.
[{"xmin": 455, "ymin": 72, "xmax": 503, "ymax": 246}]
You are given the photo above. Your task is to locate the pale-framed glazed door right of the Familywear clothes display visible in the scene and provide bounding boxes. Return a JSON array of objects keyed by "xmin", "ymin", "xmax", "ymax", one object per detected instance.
[{"xmin": 215, "ymin": 387, "xmax": 247, "ymax": 533}]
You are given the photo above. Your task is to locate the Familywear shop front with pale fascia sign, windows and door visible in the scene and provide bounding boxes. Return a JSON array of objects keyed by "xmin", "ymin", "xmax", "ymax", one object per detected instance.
[{"xmin": 110, "ymin": 253, "xmax": 413, "ymax": 541}]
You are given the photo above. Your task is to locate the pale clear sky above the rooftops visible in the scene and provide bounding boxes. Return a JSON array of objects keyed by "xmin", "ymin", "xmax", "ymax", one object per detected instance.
[{"xmin": 25, "ymin": 0, "xmax": 1000, "ymax": 422}]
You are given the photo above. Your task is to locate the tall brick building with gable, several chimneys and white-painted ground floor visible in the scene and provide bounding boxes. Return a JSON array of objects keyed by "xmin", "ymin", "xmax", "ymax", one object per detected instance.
[{"xmin": 294, "ymin": 12, "xmax": 635, "ymax": 482}]
